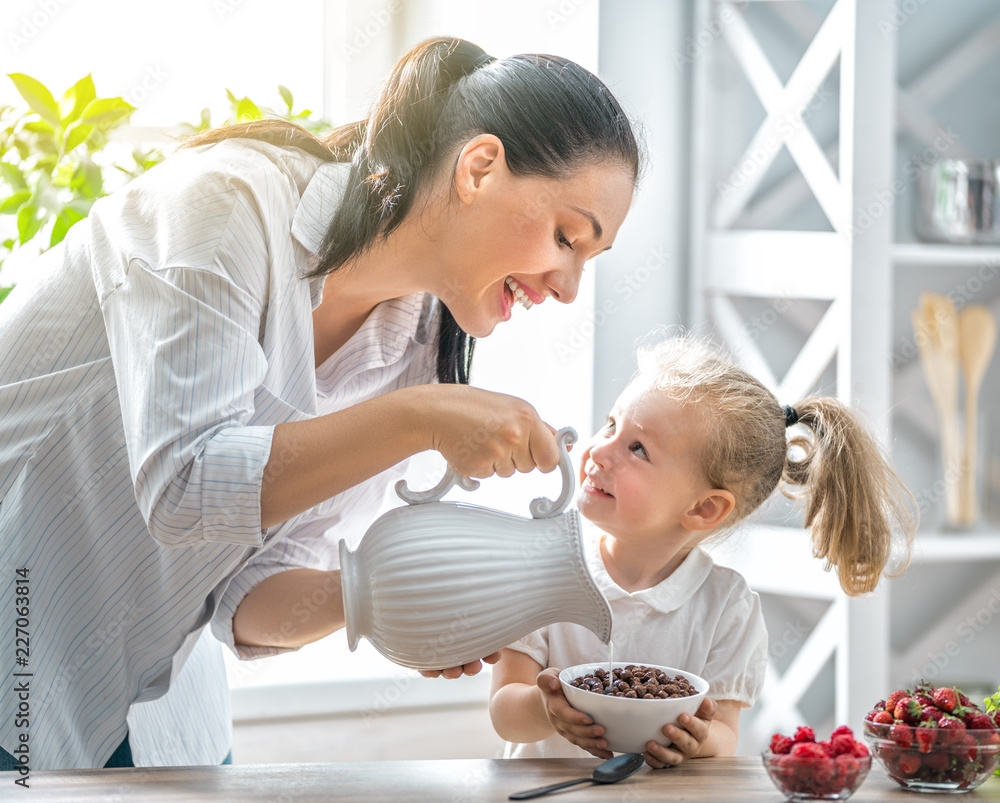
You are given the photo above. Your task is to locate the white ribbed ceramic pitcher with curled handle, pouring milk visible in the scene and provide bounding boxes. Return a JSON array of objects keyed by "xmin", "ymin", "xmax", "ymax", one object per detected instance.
[{"xmin": 340, "ymin": 427, "xmax": 611, "ymax": 670}]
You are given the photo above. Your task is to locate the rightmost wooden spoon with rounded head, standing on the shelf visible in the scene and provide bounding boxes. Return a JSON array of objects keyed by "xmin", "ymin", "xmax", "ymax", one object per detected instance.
[{"xmin": 958, "ymin": 304, "xmax": 997, "ymax": 524}]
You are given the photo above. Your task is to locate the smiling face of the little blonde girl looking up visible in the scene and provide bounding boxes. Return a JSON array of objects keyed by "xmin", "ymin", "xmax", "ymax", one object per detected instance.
[{"xmin": 577, "ymin": 383, "xmax": 711, "ymax": 546}]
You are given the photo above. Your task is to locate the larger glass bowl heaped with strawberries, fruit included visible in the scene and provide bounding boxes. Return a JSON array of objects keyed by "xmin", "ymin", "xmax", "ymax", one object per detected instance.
[{"xmin": 864, "ymin": 683, "xmax": 1000, "ymax": 793}]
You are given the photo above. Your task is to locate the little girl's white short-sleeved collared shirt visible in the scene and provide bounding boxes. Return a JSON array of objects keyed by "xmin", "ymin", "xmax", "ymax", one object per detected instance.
[{"xmin": 504, "ymin": 525, "xmax": 767, "ymax": 758}]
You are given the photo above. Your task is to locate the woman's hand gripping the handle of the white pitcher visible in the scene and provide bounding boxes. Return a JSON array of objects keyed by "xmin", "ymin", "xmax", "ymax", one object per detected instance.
[{"xmin": 428, "ymin": 385, "xmax": 559, "ymax": 478}]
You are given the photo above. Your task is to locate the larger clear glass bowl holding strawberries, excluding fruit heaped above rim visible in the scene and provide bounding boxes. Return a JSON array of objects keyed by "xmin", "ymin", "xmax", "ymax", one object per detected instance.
[{"xmin": 864, "ymin": 722, "xmax": 1000, "ymax": 794}]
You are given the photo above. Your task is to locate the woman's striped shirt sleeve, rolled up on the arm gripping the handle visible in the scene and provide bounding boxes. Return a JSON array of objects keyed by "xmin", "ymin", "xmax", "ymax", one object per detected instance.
[{"xmin": 102, "ymin": 248, "xmax": 274, "ymax": 547}]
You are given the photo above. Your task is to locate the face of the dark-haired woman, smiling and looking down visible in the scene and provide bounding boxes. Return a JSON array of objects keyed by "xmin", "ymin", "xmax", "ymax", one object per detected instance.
[{"xmin": 435, "ymin": 159, "xmax": 633, "ymax": 337}]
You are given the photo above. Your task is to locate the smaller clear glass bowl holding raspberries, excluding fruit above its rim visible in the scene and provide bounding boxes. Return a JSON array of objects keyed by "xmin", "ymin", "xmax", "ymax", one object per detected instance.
[{"xmin": 761, "ymin": 750, "xmax": 872, "ymax": 800}]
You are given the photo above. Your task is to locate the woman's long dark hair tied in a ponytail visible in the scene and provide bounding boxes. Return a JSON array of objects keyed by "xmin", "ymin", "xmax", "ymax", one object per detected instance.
[{"xmin": 185, "ymin": 38, "xmax": 640, "ymax": 384}]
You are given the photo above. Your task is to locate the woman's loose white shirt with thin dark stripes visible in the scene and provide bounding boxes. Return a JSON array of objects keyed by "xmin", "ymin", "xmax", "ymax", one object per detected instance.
[{"xmin": 0, "ymin": 140, "xmax": 436, "ymax": 769}]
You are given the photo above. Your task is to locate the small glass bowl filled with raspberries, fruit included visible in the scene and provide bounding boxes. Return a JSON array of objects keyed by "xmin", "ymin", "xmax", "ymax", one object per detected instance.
[{"xmin": 761, "ymin": 725, "xmax": 872, "ymax": 800}]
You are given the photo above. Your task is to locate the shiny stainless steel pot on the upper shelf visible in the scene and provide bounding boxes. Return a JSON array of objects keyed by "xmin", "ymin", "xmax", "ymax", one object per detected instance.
[{"xmin": 917, "ymin": 159, "xmax": 1000, "ymax": 243}]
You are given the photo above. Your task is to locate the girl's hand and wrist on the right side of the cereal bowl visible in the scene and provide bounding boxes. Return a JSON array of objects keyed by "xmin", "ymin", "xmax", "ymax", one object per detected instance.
[{"xmin": 646, "ymin": 697, "xmax": 740, "ymax": 769}]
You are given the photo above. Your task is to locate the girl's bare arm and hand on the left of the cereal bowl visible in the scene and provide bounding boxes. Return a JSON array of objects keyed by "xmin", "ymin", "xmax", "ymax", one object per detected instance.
[{"xmin": 490, "ymin": 649, "xmax": 612, "ymax": 758}]
